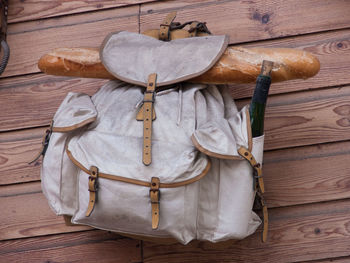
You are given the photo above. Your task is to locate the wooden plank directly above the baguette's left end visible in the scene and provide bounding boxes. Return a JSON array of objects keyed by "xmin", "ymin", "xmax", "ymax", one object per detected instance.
[{"xmin": 2, "ymin": 6, "xmax": 139, "ymax": 77}]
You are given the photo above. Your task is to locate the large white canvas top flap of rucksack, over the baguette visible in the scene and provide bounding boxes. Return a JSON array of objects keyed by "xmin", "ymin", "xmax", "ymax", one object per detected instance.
[{"xmin": 100, "ymin": 31, "xmax": 228, "ymax": 87}]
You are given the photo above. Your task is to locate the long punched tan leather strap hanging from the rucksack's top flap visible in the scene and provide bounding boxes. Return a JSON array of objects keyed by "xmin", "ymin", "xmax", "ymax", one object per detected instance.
[{"xmin": 142, "ymin": 73, "xmax": 157, "ymax": 165}]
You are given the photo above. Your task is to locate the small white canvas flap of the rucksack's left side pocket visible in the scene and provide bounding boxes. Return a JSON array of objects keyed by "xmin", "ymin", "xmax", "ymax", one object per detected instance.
[{"xmin": 52, "ymin": 92, "xmax": 97, "ymax": 132}]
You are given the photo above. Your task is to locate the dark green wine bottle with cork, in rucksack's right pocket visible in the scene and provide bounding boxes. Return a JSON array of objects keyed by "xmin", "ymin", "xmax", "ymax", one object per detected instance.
[{"xmin": 249, "ymin": 60, "xmax": 273, "ymax": 137}]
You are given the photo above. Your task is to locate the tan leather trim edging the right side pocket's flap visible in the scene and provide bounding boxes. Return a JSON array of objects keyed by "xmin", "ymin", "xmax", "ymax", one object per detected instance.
[{"xmin": 191, "ymin": 107, "xmax": 253, "ymax": 160}]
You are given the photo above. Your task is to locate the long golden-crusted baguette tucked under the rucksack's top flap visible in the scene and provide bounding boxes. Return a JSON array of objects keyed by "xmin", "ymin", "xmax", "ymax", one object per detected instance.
[{"xmin": 38, "ymin": 47, "xmax": 320, "ymax": 84}]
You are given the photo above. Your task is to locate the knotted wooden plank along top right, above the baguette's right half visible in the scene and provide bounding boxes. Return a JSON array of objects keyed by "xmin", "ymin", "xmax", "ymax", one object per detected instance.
[{"xmin": 140, "ymin": 0, "xmax": 350, "ymax": 43}]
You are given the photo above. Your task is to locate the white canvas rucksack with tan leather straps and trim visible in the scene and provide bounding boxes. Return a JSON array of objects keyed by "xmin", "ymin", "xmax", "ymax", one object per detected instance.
[{"xmin": 33, "ymin": 24, "xmax": 267, "ymax": 244}]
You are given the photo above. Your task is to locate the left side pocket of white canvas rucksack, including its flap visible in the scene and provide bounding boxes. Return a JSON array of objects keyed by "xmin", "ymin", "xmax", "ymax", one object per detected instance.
[{"xmin": 41, "ymin": 92, "xmax": 97, "ymax": 215}]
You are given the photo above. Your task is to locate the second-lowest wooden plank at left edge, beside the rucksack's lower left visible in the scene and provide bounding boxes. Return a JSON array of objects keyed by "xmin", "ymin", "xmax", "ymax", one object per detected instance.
[{"xmin": 0, "ymin": 183, "xmax": 90, "ymax": 240}]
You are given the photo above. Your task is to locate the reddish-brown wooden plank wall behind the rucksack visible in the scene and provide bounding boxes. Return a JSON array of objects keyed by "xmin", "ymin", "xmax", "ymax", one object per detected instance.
[{"xmin": 0, "ymin": 0, "xmax": 350, "ymax": 263}]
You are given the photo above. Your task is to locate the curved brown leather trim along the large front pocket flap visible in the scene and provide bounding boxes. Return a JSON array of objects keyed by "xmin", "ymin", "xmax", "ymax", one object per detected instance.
[{"xmin": 66, "ymin": 147, "xmax": 211, "ymax": 188}]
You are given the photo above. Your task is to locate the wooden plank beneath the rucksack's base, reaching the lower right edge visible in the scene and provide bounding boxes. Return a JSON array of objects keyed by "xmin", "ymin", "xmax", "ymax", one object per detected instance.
[{"xmin": 143, "ymin": 200, "xmax": 350, "ymax": 263}]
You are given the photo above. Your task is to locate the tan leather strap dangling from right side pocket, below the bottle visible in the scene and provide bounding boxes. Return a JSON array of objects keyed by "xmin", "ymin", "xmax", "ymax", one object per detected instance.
[{"xmin": 238, "ymin": 147, "xmax": 269, "ymax": 242}]
